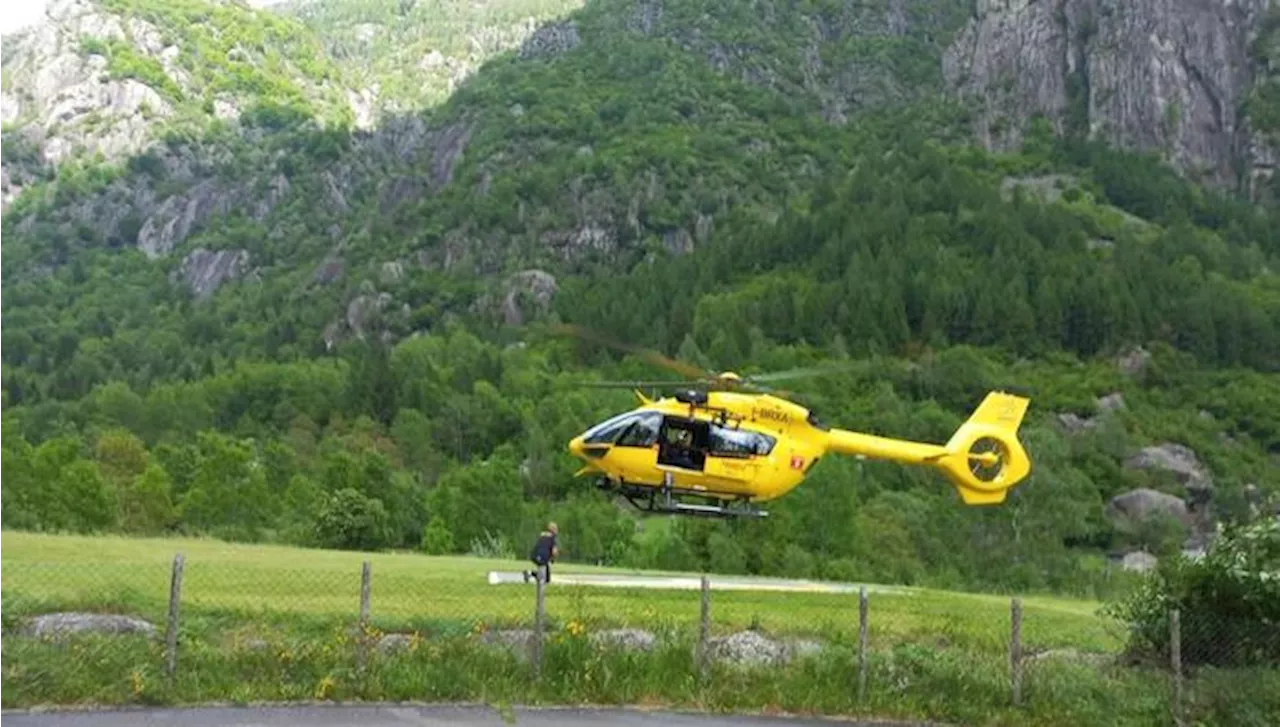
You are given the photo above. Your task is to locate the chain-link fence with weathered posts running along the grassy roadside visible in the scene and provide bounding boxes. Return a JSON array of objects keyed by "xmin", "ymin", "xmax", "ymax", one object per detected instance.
[{"xmin": 0, "ymin": 545, "xmax": 1280, "ymax": 724}]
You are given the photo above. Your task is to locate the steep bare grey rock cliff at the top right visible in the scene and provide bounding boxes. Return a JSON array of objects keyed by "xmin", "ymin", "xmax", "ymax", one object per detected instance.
[{"xmin": 943, "ymin": 0, "xmax": 1274, "ymax": 189}]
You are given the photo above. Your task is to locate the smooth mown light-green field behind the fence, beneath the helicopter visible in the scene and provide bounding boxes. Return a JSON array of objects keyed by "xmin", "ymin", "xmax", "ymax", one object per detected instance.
[{"xmin": 0, "ymin": 532, "xmax": 1120, "ymax": 651}]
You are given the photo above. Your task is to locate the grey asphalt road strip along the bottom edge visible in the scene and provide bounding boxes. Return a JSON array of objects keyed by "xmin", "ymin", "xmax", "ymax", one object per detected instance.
[{"xmin": 0, "ymin": 705, "xmax": 926, "ymax": 727}]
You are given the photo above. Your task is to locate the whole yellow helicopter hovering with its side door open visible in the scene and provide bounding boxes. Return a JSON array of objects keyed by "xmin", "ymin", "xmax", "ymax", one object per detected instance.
[{"xmin": 568, "ymin": 326, "xmax": 1032, "ymax": 517}]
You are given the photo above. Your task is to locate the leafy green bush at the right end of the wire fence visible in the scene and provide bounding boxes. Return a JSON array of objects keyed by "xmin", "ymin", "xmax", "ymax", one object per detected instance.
[{"xmin": 1107, "ymin": 518, "xmax": 1280, "ymax": 667}]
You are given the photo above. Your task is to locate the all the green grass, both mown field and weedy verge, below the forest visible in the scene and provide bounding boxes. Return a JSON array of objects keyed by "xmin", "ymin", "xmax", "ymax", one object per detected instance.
[{"xmin": 0, "ymin": 532, "xmax": 1280, "ymax": 726}]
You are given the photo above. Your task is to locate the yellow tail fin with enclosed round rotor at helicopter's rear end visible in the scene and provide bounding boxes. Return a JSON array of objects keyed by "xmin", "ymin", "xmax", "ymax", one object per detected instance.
[{"xmin": 929, "ymin": 392, "xmax": 1032, "ymax": 504}]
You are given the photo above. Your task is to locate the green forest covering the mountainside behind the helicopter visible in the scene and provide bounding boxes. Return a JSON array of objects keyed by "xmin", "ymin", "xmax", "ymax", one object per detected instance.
[{"xmin": 0, "ymin": 0, "xmax": 1280, "ymax": 595}]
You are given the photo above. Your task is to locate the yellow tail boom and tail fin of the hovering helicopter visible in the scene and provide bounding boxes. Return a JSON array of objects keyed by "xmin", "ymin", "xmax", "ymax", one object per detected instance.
[{"xmin": 829, "ymin": 392, "xmax": 1030, "ymax": 506}]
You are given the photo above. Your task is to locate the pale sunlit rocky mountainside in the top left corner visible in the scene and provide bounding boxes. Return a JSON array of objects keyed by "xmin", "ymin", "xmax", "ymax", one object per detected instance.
[{"xmin": 0, "ymin": 0, "xmax": 358, "ymax": 206}]
